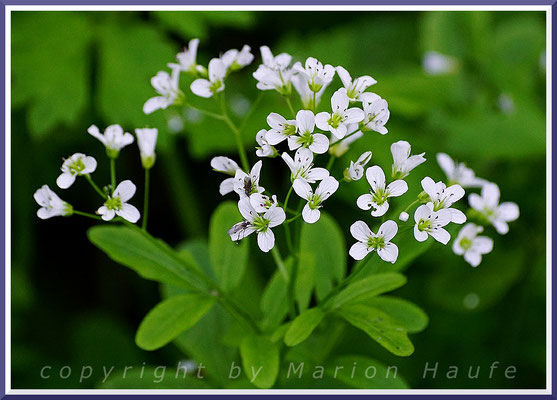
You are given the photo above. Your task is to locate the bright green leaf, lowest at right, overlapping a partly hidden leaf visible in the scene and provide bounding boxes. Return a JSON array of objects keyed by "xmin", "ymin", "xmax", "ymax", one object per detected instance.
[{"xmin": 337, "ymin": 304, "xmax": 414, "ymax": 356}]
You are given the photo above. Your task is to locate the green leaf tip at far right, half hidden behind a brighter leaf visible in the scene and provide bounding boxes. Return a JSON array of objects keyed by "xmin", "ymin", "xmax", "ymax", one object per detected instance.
[{"xmin": 366, "ymin": 296, "xmax": 429, "ymax": 333}]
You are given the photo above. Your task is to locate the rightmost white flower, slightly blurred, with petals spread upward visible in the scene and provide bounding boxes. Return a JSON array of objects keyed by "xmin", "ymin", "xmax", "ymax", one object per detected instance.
[{"xmin": 468, "ymin": 183, "xmax": 520, "ymax": 235}]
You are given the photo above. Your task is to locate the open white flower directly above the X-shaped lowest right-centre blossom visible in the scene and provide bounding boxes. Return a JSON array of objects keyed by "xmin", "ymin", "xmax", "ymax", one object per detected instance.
[{"xmin": 356, "ymin": 165, "xmax": 408, "ymax": 217}]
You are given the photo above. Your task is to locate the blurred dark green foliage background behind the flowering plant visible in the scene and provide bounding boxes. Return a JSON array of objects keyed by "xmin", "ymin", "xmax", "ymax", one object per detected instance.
[{"xmin": 11, "ymin": 11, "xmax": 546, "ymax": 389}]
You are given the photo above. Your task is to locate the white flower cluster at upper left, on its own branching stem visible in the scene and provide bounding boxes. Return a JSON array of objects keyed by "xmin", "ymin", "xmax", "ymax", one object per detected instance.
[{"xmin": 143, "ymin": 39, "xmax": 253, "ymax": 114}]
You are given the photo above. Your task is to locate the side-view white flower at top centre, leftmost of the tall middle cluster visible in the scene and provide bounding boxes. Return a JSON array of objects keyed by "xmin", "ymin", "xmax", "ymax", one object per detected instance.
[{"xmin": 253, "ymin": 46, "xmax": 292, "ymax": 96}]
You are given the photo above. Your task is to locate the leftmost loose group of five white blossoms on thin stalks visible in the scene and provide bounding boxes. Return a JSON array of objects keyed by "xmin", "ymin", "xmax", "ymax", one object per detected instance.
[{"xmin": 34, "ymin": 125, "xmax": 158, "ymax": 223}]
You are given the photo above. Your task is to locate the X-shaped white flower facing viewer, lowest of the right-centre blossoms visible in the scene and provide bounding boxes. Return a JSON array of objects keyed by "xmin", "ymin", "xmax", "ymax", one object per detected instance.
[{"xmin": 349, "ymin": 220, "xmax": 398, "ymax": 264}]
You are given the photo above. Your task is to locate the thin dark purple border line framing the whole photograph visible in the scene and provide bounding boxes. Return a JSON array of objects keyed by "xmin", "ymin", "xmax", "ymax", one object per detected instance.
[{"xmin": 0, "ymin": 0, "xmax": 557, "ymax": 400}]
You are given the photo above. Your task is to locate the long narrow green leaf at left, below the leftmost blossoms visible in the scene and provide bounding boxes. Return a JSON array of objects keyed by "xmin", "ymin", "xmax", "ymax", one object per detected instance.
[{"xmin": 87, "ymin": 226, "xmax": 207, "ymax": 291}]
